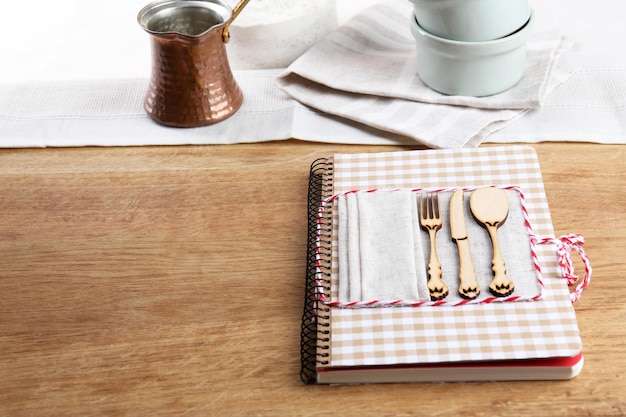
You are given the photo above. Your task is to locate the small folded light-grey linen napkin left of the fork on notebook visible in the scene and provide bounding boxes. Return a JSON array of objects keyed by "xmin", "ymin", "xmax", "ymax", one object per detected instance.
[{"xmin": 337, "ymin": 191, "xmax": 428, "ymax": 302}]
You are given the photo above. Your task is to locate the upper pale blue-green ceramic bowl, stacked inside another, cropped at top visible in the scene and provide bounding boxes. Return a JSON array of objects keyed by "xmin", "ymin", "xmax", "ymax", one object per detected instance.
[{"xmin": 409, "ymin": 0, "xmax": 530, "ymax": 42}]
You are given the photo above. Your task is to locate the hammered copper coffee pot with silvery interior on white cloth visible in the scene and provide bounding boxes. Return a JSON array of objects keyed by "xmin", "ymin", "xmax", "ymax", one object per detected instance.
[{"xmin": 137, "ymin": 0, "xmax": 250, "ymax": 127}]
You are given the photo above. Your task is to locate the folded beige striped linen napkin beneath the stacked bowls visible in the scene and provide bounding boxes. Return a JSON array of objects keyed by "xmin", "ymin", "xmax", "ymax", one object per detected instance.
[{"xmin": 278, "ymin": 0, "xmax": 570, "ymax": 148}]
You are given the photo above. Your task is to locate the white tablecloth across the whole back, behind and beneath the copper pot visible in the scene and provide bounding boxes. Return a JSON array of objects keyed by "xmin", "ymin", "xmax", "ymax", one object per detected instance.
[{"xmin": 0, "ymin": 0, "xmax": 626, "ymax": 147}]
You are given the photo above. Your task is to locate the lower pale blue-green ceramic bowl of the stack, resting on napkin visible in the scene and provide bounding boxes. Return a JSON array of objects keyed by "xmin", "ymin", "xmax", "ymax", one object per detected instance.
[{"xmin": 411, "ymin": 13, "xmax": 534, "ymax": 97}]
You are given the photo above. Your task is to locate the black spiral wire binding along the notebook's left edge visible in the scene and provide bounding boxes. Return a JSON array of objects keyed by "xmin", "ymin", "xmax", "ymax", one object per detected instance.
[{"xmin": 300, "ymin": 159, "xmax": 333, "ymax": 384}]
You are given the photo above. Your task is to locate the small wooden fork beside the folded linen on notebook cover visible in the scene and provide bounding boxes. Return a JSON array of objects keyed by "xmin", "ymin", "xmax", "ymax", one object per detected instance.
[{"xmin": 419, "ymin": 194, "xmax": 449, "ymax": 301}]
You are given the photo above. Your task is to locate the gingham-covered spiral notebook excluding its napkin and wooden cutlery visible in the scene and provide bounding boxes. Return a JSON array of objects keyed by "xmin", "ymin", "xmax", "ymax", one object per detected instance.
[{"xmin": 301, "ymin": 146, "xmax": 590, "ymax": 384}]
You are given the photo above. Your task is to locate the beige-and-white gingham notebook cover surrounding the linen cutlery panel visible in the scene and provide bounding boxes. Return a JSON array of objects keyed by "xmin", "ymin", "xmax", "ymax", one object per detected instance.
[{"xmin": 322, "ymin": 146, "xmax": 582, "ymax": 367}]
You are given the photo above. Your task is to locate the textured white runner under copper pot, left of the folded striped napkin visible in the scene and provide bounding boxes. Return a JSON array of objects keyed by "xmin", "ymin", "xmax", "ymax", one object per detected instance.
[{"xmin": 0, "ymin": 70, "xmax": 412, "ymax": 148}]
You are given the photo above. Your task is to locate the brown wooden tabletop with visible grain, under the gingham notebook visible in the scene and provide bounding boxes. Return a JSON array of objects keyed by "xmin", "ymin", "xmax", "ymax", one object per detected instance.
[{"xmin": 0, "ymin": 141, "xmax": 626, "ymax": 417}]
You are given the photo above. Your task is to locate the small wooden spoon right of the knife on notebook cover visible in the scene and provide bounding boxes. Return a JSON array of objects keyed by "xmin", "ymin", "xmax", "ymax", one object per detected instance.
[{"xmin": 470, "ymin": 187, "xmax": 515, "ymax": 297}]
